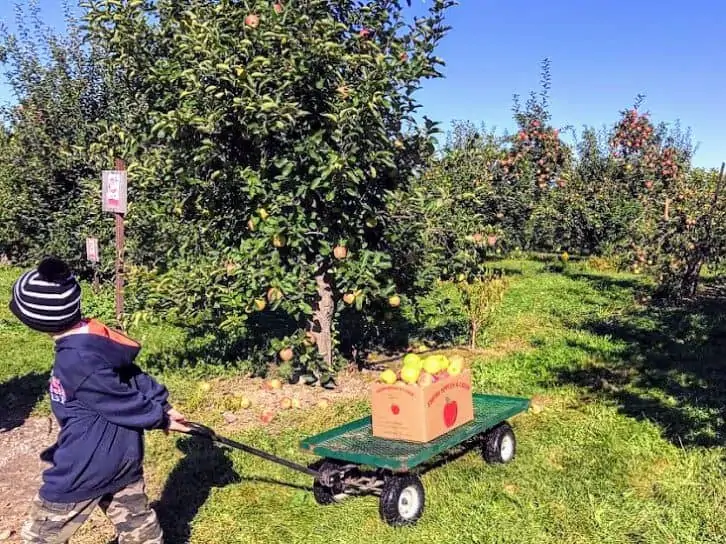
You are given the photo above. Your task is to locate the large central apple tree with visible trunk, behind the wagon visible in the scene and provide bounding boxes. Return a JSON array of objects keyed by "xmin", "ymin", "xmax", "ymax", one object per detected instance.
[{"xmin": 84, "ymin": 0, "xmax": 454, "ymax": 378}]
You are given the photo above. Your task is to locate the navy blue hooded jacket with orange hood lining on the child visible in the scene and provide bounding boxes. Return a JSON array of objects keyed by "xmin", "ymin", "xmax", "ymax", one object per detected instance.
[{"xmin": 40, "ymin": 320, "xmax": 171, "ymax": 503}]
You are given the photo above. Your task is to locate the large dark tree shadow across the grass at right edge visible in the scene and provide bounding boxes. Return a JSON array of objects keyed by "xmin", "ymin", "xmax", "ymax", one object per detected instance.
[{"xmin": 558, "ymin": 277, "xmax": 726, "ymax": 447}]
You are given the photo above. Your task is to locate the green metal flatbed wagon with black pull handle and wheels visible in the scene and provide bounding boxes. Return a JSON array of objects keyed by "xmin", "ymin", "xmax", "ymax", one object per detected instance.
[{"xmin": 190, "ymin": 395, "xmax": 529, "ymax": 527}]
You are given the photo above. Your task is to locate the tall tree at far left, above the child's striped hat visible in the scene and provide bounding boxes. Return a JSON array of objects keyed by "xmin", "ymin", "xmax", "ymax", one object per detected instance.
[{"xmin": 0, "ymin": 2, "xmax": 113, "ymax": 272}]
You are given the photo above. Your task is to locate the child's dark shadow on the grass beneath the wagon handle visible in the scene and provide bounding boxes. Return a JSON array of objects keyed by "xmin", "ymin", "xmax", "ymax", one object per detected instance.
[{"xmin": 155, "ymin": 437, "xmax": 242, "ymax": 543}]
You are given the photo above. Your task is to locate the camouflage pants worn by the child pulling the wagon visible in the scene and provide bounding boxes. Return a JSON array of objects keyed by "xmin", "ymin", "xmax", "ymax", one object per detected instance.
[{"xmin": 20, "ymin": 480, "xmax": 163, "ymax": 544}]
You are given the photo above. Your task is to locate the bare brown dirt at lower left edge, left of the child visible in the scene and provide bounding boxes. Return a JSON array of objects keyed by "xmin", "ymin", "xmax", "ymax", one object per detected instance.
[{"xmin": 0, "ymin": 417, "xmax": 58, "ymax": 542}]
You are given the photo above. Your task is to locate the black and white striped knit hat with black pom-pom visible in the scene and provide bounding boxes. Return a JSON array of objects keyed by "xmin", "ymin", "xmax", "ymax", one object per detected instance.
[{"xmin": 10, "ymin": 257, "xmax": 81, "ymax": 333}]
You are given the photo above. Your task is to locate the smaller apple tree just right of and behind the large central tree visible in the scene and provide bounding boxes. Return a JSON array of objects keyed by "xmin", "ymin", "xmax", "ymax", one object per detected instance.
[{"xmin": 389, "ymin": 123, "xmax": 503, "ymax": 294}]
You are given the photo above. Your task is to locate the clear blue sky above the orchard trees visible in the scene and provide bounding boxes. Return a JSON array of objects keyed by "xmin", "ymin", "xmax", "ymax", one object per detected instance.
[{"xmin": 0, "ymin": 0, "xmax": 726, "ymax": 167}]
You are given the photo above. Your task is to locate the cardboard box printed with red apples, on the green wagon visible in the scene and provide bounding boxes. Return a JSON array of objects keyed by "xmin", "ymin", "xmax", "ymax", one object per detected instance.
[{"xmin": 371, "ymin": 370, "xmax": 474, "ymax": 442}]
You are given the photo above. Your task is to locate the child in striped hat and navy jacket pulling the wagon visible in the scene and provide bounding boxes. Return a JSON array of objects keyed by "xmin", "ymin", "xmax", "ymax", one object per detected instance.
[{"xmin": 10, "ymin": 258, "xmax": 189, "ymax": 544}]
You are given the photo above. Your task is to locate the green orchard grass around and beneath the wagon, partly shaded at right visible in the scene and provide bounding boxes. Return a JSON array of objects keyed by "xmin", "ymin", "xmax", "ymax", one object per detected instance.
[{"xmin": 0, "ymin": 262, "xmax": 726, "ymax": 544}]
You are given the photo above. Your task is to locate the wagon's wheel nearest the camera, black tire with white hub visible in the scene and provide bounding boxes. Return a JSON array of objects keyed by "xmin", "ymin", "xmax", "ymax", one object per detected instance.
[{"xmin": 378, "ymin": 474, "xmax": 426, "ymax": 527}]
